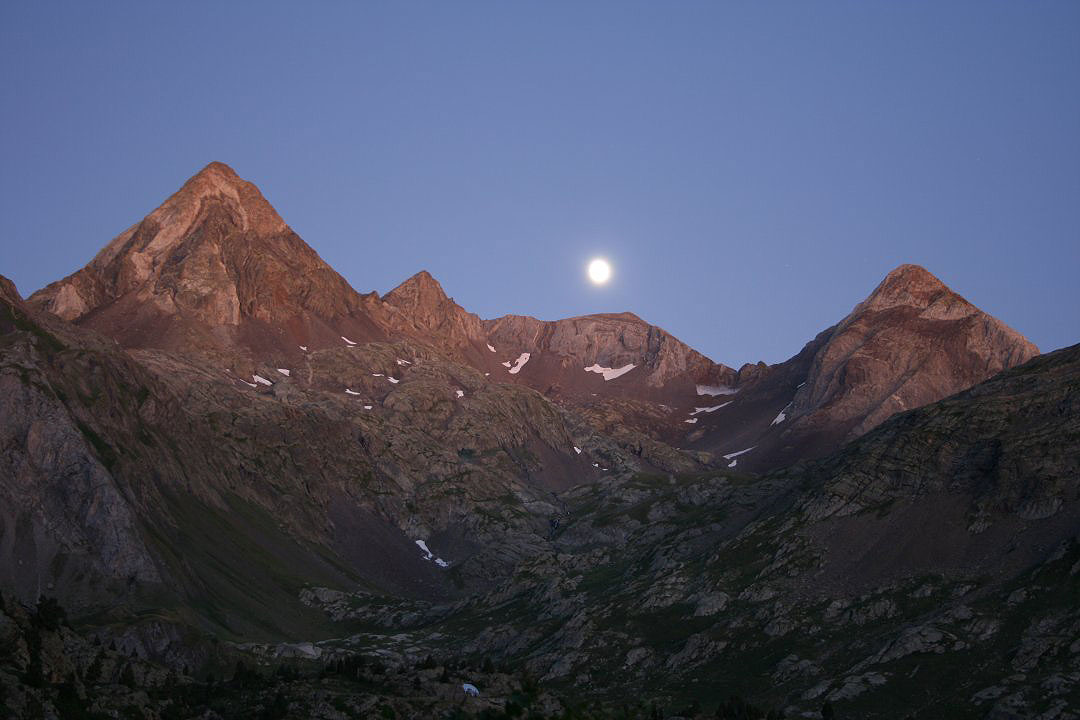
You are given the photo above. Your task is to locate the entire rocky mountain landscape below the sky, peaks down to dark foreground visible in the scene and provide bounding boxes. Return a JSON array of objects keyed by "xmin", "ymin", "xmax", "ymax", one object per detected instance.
[{"xmin": 0, "ymin": 163, "xmax": 1067, "ymax": 719}]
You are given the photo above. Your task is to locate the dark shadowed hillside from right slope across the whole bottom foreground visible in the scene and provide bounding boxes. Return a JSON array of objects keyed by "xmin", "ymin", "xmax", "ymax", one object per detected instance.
[{"xmin": 0, "ymin": 347, "xmax": 1080, "ymax": 719}]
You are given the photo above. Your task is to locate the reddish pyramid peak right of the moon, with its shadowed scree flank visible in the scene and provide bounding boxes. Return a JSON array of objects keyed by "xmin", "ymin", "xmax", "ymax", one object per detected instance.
[{"xmin": 682, "ymin": 264, "xmax": 1039, "ymax": 471}]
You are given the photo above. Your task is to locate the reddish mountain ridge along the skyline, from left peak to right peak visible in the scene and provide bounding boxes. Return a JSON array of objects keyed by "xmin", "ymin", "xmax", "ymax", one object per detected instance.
[{"xmin": 27, "ymin": 162, "xmax": 1038, "ymax": 470}]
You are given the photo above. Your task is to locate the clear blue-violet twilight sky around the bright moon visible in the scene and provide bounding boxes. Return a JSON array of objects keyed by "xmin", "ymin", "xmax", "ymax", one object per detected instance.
[{"xmin": 0, "ymin": 0, "xmax": 1080, "ymax": 367}]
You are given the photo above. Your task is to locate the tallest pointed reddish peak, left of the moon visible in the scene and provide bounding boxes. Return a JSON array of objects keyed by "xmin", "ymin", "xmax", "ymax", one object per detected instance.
[{"xmin": 29, "ymin": 162, "xmax": 378, "ymax": 348}]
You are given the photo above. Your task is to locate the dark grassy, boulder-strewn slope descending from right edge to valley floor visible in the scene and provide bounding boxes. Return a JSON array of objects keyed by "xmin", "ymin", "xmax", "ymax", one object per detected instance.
[{"xmin": 295, "ymin": 345, "xmax": 1080, "ymax": 718}]
